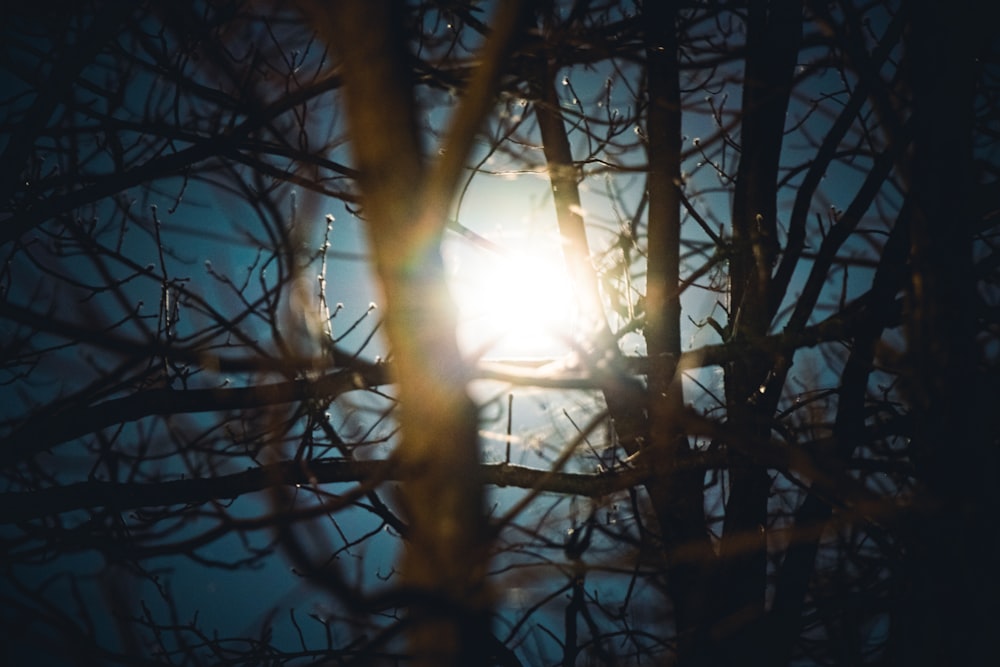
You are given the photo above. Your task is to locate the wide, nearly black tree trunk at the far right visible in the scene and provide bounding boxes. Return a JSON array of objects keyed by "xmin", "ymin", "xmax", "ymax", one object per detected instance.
[{"xmin": 900, "ymin": 0, "xmax": 998, "ymax": 665}]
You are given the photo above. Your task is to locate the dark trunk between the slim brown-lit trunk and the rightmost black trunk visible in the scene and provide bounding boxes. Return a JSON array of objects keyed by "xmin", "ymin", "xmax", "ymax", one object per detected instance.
[{"xmin": 715, "ymin": 0, "xmax": 802, "ymax": 661}]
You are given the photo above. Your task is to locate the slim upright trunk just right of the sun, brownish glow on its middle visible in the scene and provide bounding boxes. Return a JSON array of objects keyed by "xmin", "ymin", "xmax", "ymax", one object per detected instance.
[{"xmin": 643, "ymin": 3, "xmax": 714, "ymax": 665}]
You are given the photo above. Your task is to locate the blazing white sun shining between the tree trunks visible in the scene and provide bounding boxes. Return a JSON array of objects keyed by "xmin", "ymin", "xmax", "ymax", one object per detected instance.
[{"xmin": 449, "ymin": 236, "xmax": 578, "ymax": 359}]
